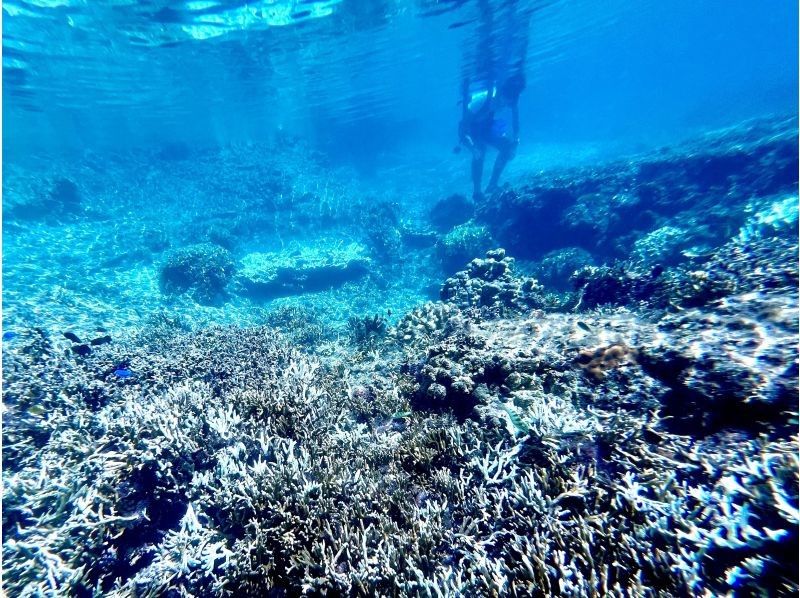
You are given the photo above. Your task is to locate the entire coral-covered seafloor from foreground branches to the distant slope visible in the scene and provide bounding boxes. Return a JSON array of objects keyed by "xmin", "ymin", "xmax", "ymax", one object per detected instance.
[{"xmin": 2, "ymin": 118, "xmax": 800, "ymax": 596}]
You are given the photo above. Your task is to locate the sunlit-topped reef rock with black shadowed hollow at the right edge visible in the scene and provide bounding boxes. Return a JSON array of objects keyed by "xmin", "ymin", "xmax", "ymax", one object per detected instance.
[{"xmin": 639, "ymin": 294, "xmax": 798, "ymax": 435}]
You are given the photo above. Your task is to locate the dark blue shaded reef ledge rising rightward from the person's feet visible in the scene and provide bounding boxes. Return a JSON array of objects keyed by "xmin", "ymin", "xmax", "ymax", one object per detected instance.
[{"xmin": 475, "ymin": 118, "xmax": 798, "ymax": 261}]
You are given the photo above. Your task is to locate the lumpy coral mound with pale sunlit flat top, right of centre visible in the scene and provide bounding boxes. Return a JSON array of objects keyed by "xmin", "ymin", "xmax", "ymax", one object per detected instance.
[{"xmin": 398, "ymin": 306, "xmax": 656, "ymax": 419}]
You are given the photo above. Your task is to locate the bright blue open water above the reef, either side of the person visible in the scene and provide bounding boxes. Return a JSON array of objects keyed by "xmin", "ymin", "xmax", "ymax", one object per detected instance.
[{"xmin": 3, "ymin": 0, "xmax": 798, "ymax": 164}]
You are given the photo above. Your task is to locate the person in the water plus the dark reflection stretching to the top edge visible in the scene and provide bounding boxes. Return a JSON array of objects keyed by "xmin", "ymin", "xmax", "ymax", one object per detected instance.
[{"xmin": 457, "ymin": 0, "xmax": 534, "ymax": 199}]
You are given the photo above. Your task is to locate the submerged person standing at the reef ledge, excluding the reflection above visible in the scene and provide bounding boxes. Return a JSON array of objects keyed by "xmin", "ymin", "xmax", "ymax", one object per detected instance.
[{"xmin": 458, "ymin": 73, "xmax": 525, "ymax": 199}]
